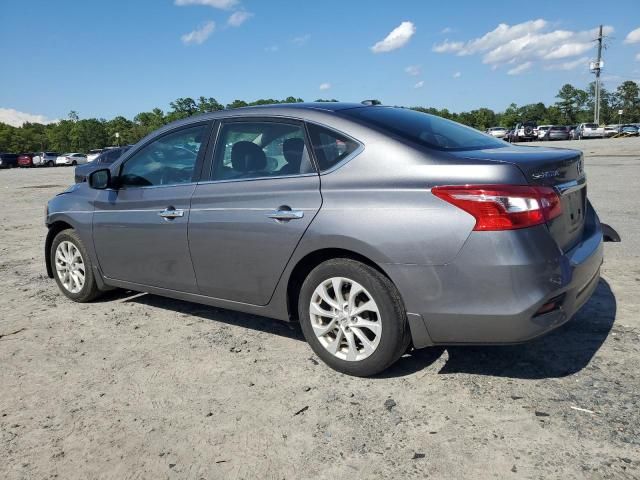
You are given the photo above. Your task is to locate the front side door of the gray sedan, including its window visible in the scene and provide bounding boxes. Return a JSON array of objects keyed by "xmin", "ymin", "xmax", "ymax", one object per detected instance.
[{"xmin": 93, "ymin": 124, "xmax": 209, "ymax": 292}]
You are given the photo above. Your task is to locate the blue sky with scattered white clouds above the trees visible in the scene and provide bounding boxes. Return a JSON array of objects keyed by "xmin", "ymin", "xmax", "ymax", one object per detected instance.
[{"xmin": 0, "ymin": 0, "xmax": 640, "ymax": 124}]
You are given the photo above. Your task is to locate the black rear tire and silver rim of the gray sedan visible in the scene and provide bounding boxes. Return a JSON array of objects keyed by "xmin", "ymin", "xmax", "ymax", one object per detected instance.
[{"xmin": 298, "ymin": 258, "xmax": 411, "ymax": 377}]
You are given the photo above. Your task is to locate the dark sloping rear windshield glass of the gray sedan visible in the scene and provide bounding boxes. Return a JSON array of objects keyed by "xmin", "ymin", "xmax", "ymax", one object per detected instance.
[{"xmin": 341, "ymin": 107, "xmax": 507, "ymax": 151}]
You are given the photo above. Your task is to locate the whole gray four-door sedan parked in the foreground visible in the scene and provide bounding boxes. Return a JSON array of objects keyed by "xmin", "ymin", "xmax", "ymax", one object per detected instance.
[{"xmin": 45, "ymin": 103, "xmax": 603, "ymax": 376}]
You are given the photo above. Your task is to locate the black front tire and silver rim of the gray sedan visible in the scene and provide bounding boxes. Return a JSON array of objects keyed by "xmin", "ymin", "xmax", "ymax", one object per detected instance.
[{"xmin": 50, "ymin": 228, "xmax": 102, "ymax": 303}]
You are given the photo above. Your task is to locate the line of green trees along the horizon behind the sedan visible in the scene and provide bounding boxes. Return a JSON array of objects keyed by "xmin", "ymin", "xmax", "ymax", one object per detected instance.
[{"xmin": 0, "ymin": 81, "xmax": 640, "ymax": 152}]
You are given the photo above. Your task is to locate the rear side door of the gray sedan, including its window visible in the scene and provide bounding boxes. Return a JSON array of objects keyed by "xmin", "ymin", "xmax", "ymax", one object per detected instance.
[{"xmin": 189, "ymin": 118, "xmax": 322, "ymax": 305}]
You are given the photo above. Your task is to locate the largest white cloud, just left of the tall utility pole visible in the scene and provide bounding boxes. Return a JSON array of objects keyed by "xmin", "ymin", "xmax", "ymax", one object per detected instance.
[{"xmin": 433, "ymin": 19, "xmax": 613, "ymax": 72}]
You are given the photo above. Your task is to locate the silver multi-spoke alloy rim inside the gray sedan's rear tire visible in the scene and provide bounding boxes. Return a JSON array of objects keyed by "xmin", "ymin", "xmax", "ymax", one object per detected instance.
[{"xmin": 309, "ymin": 277, "xmax": 382, "ymax": 362}]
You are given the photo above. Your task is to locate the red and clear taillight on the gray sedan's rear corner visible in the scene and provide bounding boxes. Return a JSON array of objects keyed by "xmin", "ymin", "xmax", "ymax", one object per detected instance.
[{"xmin": 431, "ymin": 185, "xmax": 562, "ymax": 231}]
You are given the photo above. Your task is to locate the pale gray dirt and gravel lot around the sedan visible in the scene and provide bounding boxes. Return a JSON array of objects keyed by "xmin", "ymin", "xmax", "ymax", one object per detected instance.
[{"xmin": 0, "ymin": 139, "xmax": 640, "ymax": 479}]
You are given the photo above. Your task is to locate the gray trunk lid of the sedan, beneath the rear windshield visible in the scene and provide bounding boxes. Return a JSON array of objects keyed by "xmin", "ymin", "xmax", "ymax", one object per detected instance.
[{"xmin": 454, "ymin": 146, "xmax": 587, "ymax": 252}]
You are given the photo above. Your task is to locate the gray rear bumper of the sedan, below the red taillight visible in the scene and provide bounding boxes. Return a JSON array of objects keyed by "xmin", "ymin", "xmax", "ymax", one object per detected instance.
[{"xmin": 385, "ymin": 206, "xmax": 603, "ymax": 347}]
